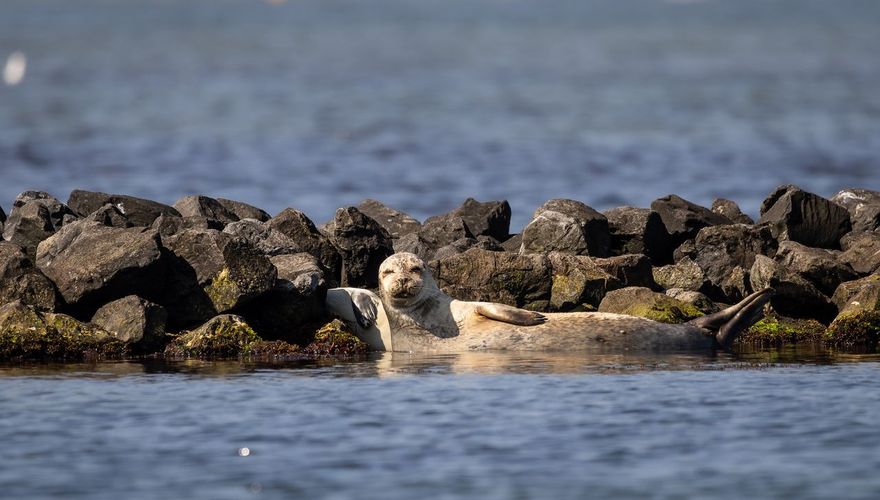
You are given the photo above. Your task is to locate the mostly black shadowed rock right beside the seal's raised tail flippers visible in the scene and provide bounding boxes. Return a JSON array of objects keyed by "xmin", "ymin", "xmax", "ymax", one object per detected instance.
[{"xmin": 749, "ymin": 255, "xmax": 837, "ymax": 323}]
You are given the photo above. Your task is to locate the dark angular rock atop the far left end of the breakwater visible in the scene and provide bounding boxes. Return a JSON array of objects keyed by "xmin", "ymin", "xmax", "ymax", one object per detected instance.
[{"xmin": 3, "ymin": 191, "xmax": 77, "ymax": 256}]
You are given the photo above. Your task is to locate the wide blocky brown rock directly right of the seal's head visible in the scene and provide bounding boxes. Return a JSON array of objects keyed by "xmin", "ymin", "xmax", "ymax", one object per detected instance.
[{"xmin": 431, "ymin": 248, "xmax": 552, "ymax": 310}]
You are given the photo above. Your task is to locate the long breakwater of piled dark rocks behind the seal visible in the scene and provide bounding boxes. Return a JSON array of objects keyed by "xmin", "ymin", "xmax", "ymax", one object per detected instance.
[{"xmin": 0, "ymin": 186, "xmax": 880, "ymax": 360}]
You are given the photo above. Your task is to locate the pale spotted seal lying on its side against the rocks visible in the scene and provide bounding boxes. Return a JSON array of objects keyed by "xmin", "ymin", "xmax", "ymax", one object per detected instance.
[{"xmin": 327, "ymin": 253, "xmax": 772, "ymax": 353}]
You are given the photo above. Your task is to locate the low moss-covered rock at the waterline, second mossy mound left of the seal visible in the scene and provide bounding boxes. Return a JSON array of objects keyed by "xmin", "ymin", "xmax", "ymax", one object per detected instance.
[{"xmin": 165, "ymin": 314, "xmax": 262, "ymax": 358}]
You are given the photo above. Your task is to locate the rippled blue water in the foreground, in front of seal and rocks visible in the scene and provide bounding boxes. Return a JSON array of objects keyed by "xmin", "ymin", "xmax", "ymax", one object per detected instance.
[{"xmin": 0, "ymin": 353, "xmax": 880, "ymax": 499}]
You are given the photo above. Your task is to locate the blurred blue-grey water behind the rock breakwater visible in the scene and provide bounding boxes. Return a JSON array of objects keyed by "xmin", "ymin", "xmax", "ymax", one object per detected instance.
[{"xmin": 0, "ymin": 0, "xmax": 880, "ymax": 231}]
